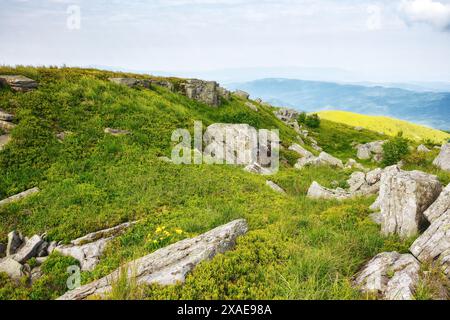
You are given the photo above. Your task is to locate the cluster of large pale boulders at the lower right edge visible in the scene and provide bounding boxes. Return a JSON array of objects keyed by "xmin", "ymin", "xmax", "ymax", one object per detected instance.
[{"xmin": 355, "ymin": 162, "xmax": 450, "ymax": 300}]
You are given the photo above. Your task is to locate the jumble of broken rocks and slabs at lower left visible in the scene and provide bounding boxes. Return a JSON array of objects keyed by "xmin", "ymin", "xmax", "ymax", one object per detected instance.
[{"xmin": 0, "ymin": 222, "xmax": 136, "ymax": 282}]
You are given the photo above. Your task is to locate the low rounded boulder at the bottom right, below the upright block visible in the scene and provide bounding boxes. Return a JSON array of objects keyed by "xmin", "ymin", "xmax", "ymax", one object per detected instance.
[{"xmin": 355, "ymin": 252, "xmax": 420, "ymax": 300}]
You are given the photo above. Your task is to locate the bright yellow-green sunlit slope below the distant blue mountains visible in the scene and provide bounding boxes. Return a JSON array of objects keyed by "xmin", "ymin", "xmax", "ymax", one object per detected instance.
[{"xmin": 319, "ymin": 111, "xmax": 450, "ymax": 143}]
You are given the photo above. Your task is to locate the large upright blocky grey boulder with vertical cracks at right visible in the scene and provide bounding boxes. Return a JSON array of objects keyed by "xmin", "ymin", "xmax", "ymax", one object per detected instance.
[{"xmin": 379, "ymin": 166, "xmax": 442, "ymax": 238}]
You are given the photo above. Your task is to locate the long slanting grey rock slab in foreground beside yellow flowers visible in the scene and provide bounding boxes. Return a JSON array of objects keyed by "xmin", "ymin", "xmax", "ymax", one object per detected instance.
[{"xmin": 58, "ymin": 220, "xmax": 248, "ymax": 300}]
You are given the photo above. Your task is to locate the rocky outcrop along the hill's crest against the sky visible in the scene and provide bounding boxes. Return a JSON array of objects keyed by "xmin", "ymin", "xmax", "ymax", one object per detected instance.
[{"xmin": 109, "ymin": 78, "xmax": 231, "ymax": 107}]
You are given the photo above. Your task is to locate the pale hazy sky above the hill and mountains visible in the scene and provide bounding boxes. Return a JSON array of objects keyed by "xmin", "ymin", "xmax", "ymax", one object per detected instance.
[{"xmin": 0, "ymin": 0, "xmax": 450, "ymax": 82}]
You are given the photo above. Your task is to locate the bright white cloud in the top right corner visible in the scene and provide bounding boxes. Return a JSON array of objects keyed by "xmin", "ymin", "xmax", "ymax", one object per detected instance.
[{"xmin": 400, "ymin": 0, "xmax": 450, "ymax": 31}]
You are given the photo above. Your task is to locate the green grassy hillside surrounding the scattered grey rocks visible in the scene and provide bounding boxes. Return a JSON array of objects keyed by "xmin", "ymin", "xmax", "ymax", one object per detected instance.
[{"xmin": 0, "ymin": 67, "xmax": 450, "ymax": 299}]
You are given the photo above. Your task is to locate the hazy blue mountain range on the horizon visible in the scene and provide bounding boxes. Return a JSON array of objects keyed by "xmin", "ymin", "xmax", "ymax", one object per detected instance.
[{"xmin": 227, "ymin": 78, "xmax": 450, "ymax": 131}]
